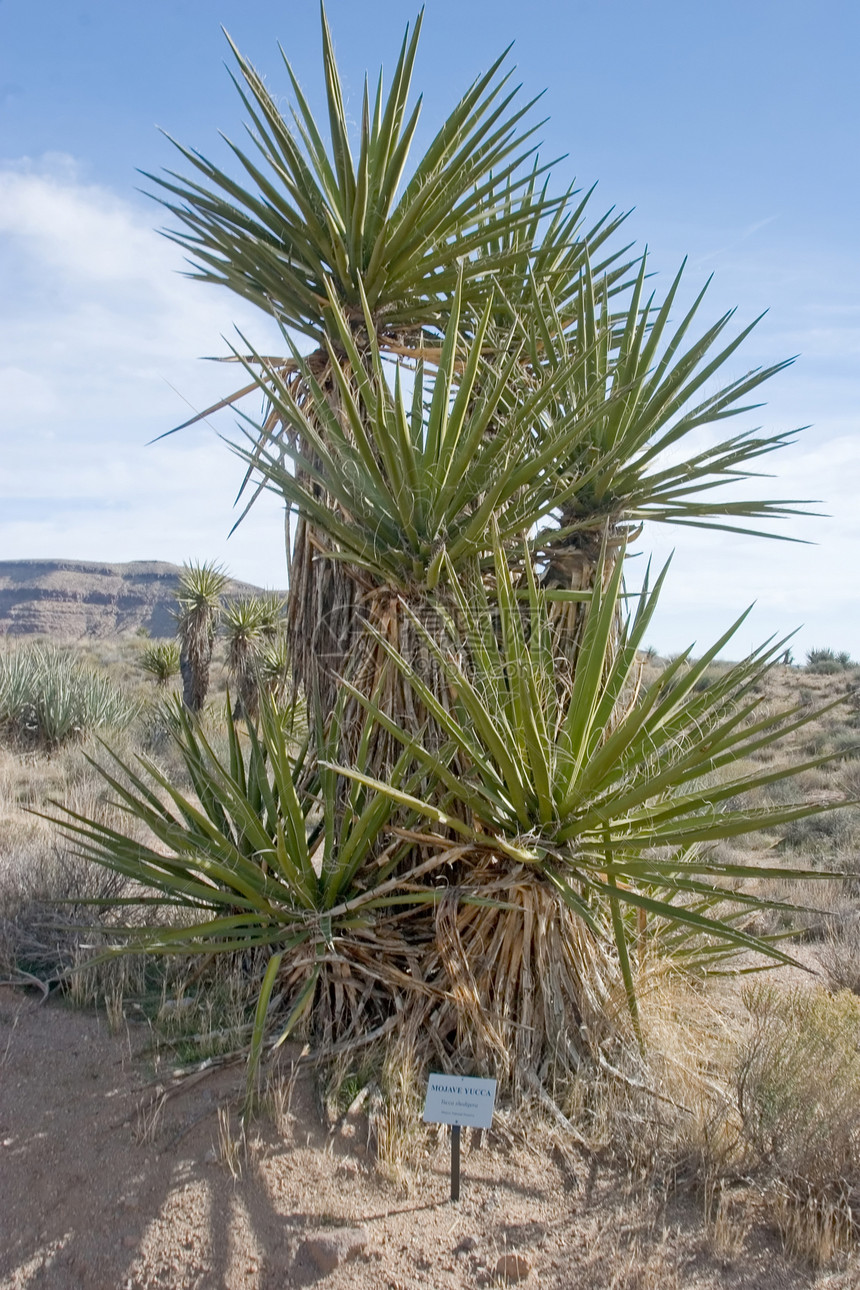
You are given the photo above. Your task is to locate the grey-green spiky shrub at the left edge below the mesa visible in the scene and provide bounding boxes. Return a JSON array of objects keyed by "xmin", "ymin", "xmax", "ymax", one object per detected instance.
[{"xmin": 0, "ymin": 645, "xmax": 137, "ymax": 748}]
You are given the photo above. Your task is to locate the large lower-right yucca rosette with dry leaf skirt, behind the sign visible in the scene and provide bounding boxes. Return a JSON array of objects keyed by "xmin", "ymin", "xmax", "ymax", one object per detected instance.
[{"xmin": 338, "ymin": 542, "xmax": 834, "ymax": 1075}]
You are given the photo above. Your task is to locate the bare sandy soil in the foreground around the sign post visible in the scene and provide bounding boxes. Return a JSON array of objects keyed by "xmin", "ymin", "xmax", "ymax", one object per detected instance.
[{"xmin": 0, "ymin": 988, "xmax": 860, "ymax": 1290}]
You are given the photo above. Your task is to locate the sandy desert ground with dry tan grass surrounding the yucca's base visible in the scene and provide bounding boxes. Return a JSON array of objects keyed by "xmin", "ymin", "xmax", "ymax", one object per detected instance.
[{"xmin": 0, "ymin": 655, "xmax": 860, "ymax": 1290}]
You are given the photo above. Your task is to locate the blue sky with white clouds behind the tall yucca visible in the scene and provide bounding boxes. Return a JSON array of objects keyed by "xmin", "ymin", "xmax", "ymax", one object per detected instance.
[{"xmin": 0, "ymin": 0, "xmax": 860, "ymax": 657}]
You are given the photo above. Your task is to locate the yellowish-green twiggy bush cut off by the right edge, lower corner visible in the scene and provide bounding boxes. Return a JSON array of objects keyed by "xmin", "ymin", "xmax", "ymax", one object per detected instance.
[{"xmin": 736, "ymin": 986, "xmax": 860, "ymax": 1263}]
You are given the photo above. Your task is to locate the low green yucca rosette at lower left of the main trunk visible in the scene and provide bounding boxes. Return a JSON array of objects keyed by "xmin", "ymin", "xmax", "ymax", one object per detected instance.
[{"xmin": 53, "ymin": 700, "xmax": 456, "ymax": 1109}]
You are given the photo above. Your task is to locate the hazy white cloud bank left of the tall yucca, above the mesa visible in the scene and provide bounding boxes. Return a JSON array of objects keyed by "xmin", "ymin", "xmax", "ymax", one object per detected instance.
[{"xmin": 0, "ymin": 156, "xmax": 284, "ymax": 584}]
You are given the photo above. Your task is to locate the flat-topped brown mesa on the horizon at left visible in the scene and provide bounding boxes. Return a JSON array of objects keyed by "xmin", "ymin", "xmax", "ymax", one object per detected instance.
[{"xmin": 0, "ymin": 560, "xmax": 275, "ymax": 641}]
